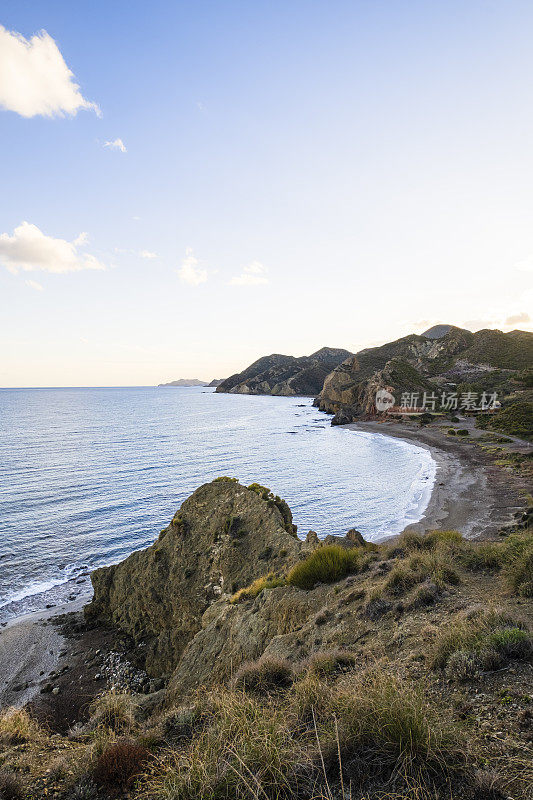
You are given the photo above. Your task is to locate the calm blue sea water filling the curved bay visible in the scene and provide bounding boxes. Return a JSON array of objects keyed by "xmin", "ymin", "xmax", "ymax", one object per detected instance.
[{"xmin": 0, "ymin": 388, "xmax": 435, "ymax": 620}]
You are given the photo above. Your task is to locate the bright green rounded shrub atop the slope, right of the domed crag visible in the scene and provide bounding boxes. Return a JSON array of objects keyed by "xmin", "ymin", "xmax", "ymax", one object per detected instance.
[{"xmin": 287, "ymin": 544, "xmax": 363, "ymax": 589}]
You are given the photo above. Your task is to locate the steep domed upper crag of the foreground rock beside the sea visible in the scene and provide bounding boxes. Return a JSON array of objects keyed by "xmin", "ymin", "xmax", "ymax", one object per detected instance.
[{"xmin": 86, "ymin": 479, "xmax": 301, "ymax": 675}]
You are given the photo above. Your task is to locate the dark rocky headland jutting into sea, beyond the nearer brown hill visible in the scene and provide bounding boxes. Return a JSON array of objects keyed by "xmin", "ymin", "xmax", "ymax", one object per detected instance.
[{"xmin": 217, "ymin": 347, "xmax": 351, "ymax": 397}]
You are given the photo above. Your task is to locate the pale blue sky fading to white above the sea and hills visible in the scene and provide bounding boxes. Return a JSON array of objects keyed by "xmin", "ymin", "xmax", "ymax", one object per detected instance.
[{"xmin": 0, "ymin": 0, "xmax": 533, "ymax": 386}]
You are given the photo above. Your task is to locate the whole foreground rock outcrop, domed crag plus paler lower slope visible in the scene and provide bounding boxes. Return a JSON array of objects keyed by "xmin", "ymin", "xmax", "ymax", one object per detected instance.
[{"xmin": 85, "ymin": 478, "xmax": 365, "ymax": 694}]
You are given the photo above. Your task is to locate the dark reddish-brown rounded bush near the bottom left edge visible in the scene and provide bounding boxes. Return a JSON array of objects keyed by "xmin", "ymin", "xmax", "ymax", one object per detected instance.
[{"xmin": 92, "ymin": 739, "xmax": 150, "ymax": 797}]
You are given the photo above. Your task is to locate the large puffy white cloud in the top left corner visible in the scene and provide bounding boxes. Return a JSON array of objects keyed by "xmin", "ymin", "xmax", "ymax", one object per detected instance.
[{"xmin": 0, "ymin": 25, "xmax": 101, "ymax": 117}]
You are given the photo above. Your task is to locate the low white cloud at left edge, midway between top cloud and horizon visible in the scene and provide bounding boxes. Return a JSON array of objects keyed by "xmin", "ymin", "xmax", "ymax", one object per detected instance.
[{"xmin": 0, "ymin": 222, "xmax": 105, "ymax": 274}]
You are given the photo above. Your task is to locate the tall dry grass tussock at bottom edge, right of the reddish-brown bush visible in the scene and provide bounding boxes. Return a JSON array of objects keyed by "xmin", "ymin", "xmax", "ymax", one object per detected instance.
[{"xmin": 144, "ymin": 689, "xmax": 317, "ymax": 800}]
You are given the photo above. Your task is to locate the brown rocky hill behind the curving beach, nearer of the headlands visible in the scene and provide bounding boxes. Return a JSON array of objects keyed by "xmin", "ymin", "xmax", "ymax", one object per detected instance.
[{"xmin": 315, "ymin": 325, "xmax": 533, "ymax": 424}]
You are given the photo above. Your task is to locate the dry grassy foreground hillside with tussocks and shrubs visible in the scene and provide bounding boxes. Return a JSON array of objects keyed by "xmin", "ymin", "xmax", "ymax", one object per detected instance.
[{"xmin": 0, "ymin": 527, "xmax": 533, "ymax": 800}]
